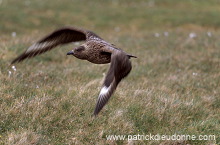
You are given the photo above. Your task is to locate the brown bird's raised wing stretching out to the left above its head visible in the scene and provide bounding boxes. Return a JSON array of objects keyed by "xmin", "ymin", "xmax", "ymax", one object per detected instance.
[{"xmin": 12, "ymin": 27, "xmax": 101, "ymax": 64}]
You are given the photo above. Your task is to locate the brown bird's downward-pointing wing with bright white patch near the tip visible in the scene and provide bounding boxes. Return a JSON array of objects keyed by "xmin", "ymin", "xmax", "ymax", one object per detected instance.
[{"xmin": 94, "ymin": 50, "xmax": 132, "ymax": 116}]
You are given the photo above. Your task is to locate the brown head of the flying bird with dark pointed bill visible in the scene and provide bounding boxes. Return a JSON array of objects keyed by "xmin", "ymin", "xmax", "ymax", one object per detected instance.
[{"xmin": 66, "ymin": 45, "xmax": 87, "ymax": 59}]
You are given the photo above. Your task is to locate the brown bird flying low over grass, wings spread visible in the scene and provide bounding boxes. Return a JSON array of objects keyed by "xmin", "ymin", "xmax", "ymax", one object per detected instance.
[{"xmin": 12, "ymin": 27, "xmax": 137, "ymax": 116}]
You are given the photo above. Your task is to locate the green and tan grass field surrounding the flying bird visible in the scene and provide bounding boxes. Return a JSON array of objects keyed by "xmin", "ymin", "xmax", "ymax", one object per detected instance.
[{"xmin": 0, "ymin": 0, "xmax": 220, "ymax": 145}]
